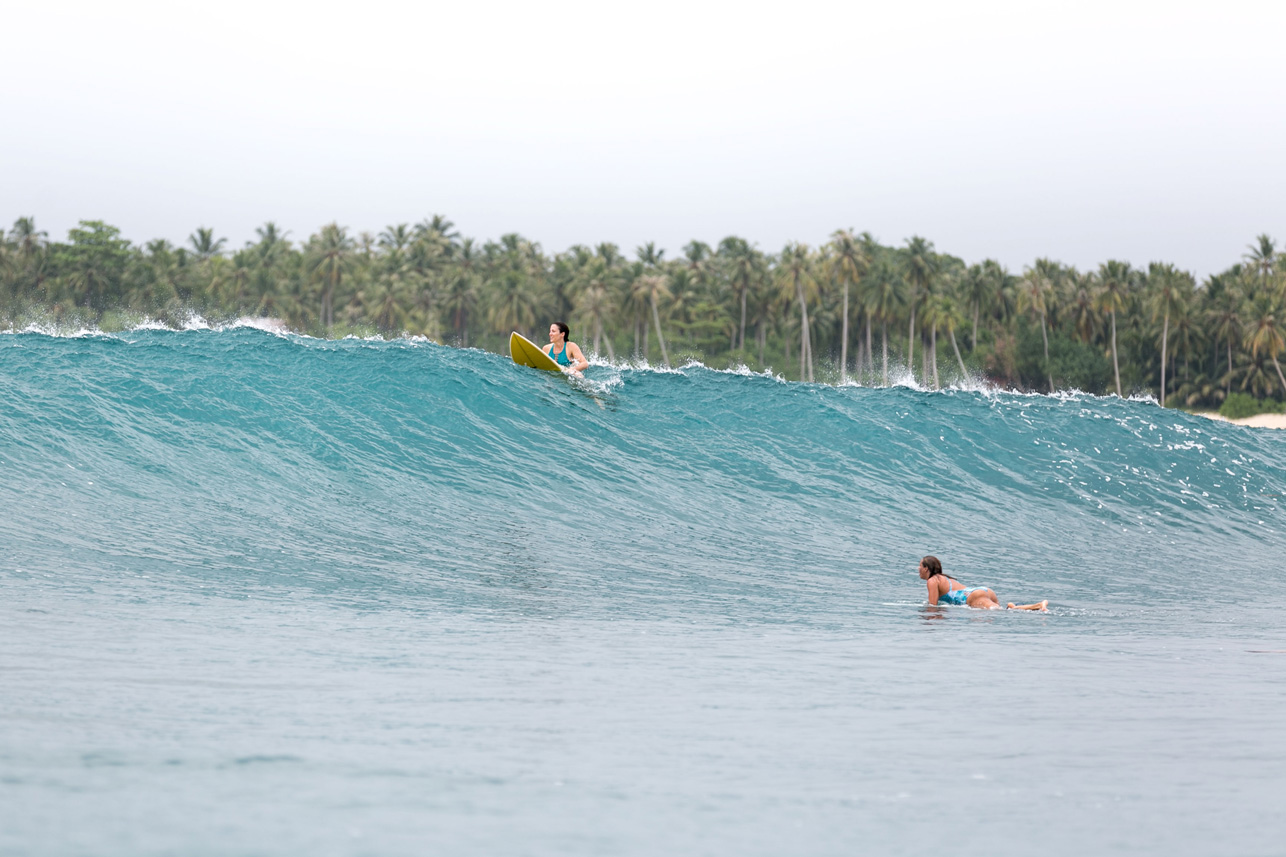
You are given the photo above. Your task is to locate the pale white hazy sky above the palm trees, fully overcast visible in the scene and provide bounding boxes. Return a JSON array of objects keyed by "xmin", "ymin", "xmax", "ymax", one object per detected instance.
[{"xmin": 0, "ymin": 0, "xmax": 1286, "ymax": 275}]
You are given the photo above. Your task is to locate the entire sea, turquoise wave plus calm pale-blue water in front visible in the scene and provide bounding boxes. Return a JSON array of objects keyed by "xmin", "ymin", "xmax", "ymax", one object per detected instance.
[{"xmin": 0, "ymin": 328, "xmax": 1286, "ymax": 856}]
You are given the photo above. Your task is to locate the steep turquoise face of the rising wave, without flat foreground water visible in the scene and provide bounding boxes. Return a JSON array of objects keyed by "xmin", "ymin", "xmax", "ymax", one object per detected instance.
[{"xmin": 0, "ymin": 329, "xmax": 1286, "ymax": 609}]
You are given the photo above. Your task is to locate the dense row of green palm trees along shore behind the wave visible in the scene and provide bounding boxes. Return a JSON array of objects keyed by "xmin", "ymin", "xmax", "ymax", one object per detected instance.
[{"xmin": 0, "ymin": 215, "xmax": 1286, "ymax": 407}]
